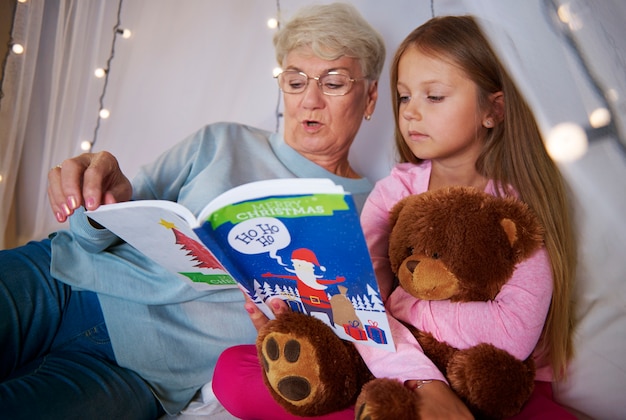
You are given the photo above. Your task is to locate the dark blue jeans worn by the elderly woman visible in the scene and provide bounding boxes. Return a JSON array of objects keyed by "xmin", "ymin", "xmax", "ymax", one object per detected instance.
[{"xmin": 0, "ymin": 240, "xmax": 164, "ymax": 419}]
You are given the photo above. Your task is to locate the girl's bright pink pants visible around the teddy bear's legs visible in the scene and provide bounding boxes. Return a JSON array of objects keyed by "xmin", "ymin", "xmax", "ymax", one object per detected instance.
[{"xmin": 213, "ymin": 344, "xmax": 576, "ymax": 420}]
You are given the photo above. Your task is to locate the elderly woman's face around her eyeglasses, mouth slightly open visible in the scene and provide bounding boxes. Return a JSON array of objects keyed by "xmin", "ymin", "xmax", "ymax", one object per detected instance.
[{"xmin": 283, "ymin": 47, "xmax": 378, "ymax": 171}]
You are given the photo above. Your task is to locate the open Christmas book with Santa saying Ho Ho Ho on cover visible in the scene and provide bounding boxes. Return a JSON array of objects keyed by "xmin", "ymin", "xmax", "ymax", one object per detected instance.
[{"xmin": 87, "ymin": 178, "xmax": 395, "ymax": 351}]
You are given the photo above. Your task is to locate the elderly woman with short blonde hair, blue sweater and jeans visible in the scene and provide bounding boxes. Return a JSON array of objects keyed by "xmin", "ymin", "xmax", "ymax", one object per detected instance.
[{"xmin": 0, "ymin": 4, "xmax": 385, "ymax": 419}]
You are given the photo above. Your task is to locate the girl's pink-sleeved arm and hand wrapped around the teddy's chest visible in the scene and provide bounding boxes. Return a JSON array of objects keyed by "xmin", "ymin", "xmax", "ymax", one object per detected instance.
[{"xmin": 387, "ymin": 248, "xmax": 552, "ymax": 359}]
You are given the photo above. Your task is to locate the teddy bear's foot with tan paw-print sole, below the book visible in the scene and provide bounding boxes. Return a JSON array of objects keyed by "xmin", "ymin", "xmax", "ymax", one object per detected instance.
[{"xmin": 257, "ymin": 312, "xmax": 371, "ymax": 416}]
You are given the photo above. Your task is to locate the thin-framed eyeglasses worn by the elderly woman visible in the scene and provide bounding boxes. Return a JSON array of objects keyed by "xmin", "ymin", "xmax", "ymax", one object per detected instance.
[{"xmin": 274, "ymin": 70, "xmax": 365, "ymax": 96}]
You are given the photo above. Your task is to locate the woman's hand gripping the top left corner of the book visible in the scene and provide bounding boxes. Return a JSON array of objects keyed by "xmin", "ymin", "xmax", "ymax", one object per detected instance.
[{"xmin": 48, "ymin": 152, "xmax": 132, "ymax": 222}]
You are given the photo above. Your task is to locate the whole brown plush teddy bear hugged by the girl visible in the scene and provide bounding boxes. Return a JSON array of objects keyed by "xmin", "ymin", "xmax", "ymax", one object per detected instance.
[{"xmin": 257, "ymin": 187, "xmax": 543, "ymax": 420}]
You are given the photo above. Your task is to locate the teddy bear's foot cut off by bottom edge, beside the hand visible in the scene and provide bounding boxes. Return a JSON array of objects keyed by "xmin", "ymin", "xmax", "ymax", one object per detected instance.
[{"xmin": 355, "ymin": 379, "xmax": 420, "ymax": 420}]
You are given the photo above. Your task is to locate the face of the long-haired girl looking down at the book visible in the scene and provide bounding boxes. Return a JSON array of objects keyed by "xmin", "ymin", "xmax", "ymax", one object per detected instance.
[{"xmin": 397, "ymin": 48, "xmax": 488, "ymax": 166}]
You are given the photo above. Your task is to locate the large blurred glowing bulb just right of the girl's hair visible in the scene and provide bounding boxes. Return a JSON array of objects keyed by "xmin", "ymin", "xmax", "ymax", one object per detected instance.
[{"xmin": 546, "ymin": 122, "xmax": 588, "ymax": 162}]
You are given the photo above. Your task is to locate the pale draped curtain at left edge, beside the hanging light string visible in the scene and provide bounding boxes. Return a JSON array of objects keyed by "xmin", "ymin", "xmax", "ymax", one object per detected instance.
[{"xmin": 0, "ymin": 0, "xmax": 116, "ymax": 248}]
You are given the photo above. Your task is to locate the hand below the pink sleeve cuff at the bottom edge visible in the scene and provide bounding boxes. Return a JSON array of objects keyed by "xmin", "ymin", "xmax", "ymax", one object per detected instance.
[{"xmin": 404, "ymin": 381, "xmax": 474, "ymax": 419}]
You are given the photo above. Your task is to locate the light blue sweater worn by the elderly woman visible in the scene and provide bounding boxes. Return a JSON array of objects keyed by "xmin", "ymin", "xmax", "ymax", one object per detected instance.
[{"xmin": 51, "ymin": 123, "xmax": 372, "ymax": 414}]
